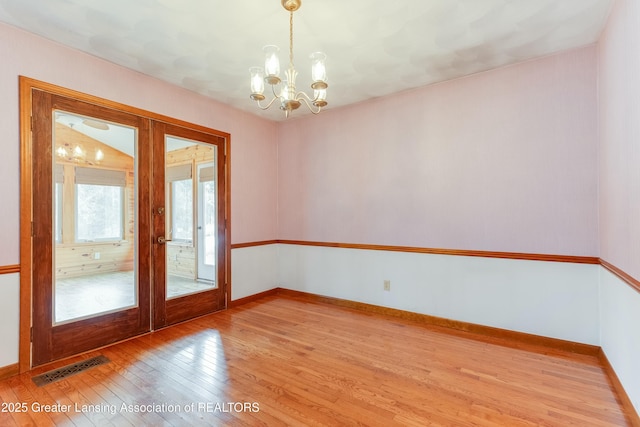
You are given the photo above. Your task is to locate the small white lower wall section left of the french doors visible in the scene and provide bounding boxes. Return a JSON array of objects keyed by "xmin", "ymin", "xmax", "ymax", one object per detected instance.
[{"xmin": 0, "ymin": 273, "xmax": 20, "ymax": 368}]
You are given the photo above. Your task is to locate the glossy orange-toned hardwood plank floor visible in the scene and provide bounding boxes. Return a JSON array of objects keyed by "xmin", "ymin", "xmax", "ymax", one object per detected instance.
[{"xmin": 0, "ymin": 296, "xmax": 632, "ymax": 427}]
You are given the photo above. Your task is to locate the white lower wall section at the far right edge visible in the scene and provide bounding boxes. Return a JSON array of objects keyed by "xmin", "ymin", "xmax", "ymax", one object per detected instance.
[{"xmin": 600, "ymin": 268, "xmax": 640, "ymax": 414}]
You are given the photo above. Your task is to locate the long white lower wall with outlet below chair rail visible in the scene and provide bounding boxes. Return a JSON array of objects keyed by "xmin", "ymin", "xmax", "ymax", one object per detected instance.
[{"xmin": 278, "ymin": 244, "xmax": 600, "ymax": 345}]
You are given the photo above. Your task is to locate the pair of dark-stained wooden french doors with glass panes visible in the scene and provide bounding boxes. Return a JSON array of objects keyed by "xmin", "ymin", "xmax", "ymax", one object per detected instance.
[{"xmin": 31, "ymin": 89, "xmax": 227, "ymax": 366}]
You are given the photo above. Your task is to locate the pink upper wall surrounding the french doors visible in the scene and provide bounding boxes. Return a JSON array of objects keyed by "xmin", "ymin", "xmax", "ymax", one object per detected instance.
[{"xmin": 0, "ymin": 24, "xmax": 277, "ymax": 266}]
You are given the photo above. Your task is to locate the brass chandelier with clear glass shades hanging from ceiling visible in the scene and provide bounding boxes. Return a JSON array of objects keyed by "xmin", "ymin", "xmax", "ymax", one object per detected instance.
[{"xmin": 249, "ymin": 0, "xmax": 328, "ymax": 117}]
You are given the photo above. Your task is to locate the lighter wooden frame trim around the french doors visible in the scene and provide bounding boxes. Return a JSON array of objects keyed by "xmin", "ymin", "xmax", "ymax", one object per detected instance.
[{"xmin": 18, "ymin": 76, "xmax": 231, "ymax": 372}]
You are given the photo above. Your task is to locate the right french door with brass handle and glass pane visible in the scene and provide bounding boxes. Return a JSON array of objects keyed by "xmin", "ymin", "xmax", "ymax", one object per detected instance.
[{"xmin": 152, "ymin": 122, "xmax": 226, "ymax": 328}]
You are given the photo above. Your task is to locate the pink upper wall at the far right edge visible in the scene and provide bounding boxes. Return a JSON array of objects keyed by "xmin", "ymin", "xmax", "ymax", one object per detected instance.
[{"xmin": 598, "ymin": 0, "xmax": 640, "ymax": 280}]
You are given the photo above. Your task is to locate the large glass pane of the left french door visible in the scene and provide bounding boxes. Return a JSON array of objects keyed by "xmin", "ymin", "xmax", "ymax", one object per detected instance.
[{"xmin": 52, "ymin": 110, "xmax": 138, "ymax": 325}]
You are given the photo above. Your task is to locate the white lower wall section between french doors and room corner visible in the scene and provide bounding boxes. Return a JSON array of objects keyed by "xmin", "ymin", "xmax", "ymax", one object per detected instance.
[{"xmin": 231, "ymin": 244, "xmax": 278, "ymax": 301}]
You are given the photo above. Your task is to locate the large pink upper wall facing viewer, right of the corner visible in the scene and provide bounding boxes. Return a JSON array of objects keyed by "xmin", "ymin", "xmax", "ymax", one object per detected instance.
[{"xmin": 278, "ymin": 46, "xmax": 598, "ymax": 256}]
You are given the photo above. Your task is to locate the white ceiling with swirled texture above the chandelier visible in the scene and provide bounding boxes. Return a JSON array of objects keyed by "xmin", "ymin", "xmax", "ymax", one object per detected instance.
[{"xmin": 0, "ymin": 0, "xmax": 613, "ymax": 120}]
